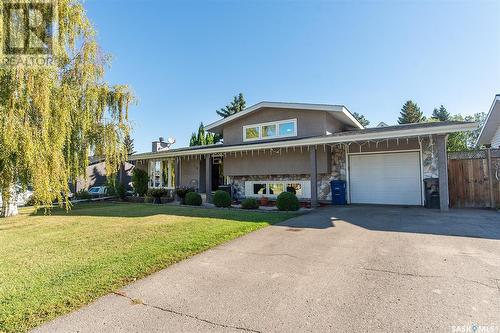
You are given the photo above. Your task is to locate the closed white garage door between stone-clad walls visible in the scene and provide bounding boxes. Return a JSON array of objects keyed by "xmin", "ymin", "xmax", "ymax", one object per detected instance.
[{"xmin": 349, "ymin": 152, "xmax": 422, "ymax": 205}]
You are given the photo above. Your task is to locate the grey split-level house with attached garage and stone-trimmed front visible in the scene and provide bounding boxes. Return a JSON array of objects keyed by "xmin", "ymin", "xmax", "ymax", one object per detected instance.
[{"xmin": 130, "ymin": 102, "xmax": 477, "ymax": 210}]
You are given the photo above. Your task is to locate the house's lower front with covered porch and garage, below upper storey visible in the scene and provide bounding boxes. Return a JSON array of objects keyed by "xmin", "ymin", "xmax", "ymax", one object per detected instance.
[{"xmin": 128, "ymin": 134, "xmax": 449, "ymax": 210}]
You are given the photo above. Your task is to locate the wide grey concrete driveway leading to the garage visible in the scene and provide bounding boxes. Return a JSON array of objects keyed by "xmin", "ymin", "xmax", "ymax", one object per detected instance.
[{"xmin": 36, "ymin": 206, "xmax": 500, "ymax": 332}]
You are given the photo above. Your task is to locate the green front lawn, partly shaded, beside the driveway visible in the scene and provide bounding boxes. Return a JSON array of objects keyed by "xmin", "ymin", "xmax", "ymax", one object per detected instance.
[{"xmin": 0, "ymin": 203, "xmax": 295, "ymax": 332}]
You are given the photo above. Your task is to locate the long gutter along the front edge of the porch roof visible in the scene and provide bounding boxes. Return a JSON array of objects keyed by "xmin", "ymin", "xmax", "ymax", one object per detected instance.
[{"xmin": 129, "ymin": 123, "xmax": 478, "ymax": 161}]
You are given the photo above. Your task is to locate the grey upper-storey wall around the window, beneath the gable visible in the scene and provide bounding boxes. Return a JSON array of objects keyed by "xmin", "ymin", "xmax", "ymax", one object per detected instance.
[{"xmin": 223, "ymin": 108, "xmax": 342, "ymax": 144}]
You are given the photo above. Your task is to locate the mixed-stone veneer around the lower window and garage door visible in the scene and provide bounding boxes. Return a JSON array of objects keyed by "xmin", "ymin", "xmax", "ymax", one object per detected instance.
[{"xmin": 229, "ymin": 138, "xmax": 438, "ymax": 201}]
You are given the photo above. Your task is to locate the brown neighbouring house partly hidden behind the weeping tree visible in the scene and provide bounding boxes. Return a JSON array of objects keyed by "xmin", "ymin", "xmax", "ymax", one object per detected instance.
[{"xmin": 70, "ymin": 157, "xmax": 134, "ymax": 193}]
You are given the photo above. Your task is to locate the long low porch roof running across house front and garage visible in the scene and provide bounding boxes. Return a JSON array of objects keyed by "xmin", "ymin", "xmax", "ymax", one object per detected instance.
[{"xmin": 129, "ymin": 121, "xmax": 478, "ymax": 161}]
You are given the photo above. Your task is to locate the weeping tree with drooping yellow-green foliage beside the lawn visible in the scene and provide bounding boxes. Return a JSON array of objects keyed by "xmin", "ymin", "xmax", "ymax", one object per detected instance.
[{"xmin": 0, "ymin": 0, "xmax": 133, "ymax": 216}]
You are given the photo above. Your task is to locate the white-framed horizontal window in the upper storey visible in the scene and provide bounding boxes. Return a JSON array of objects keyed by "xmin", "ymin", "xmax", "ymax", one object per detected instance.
[{"xmin": 243, "ymin": 119, "xmax": 297, "ymax": 141}]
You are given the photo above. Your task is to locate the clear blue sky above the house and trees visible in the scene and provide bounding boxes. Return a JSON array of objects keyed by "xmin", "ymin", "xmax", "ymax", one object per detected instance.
[{"xmin": 85, "ymin": 0, "xmax": 500, "ymax": 152}]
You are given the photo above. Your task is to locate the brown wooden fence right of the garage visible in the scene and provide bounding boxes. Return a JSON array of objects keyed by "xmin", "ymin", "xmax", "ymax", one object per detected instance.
[{"xmin": 448, "ymin": 149, "xmax": 500, "ymax": 208}]
